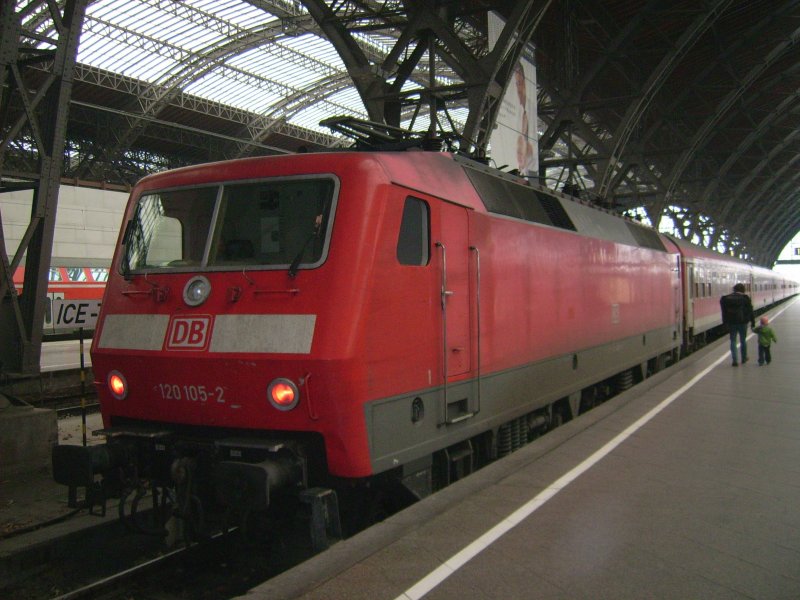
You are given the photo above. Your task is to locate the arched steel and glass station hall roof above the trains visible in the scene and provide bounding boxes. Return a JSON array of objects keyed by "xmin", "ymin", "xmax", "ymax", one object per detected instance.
[{"xmin": 0, "ymin": 0, "xmax": 800, "ymax": 376}]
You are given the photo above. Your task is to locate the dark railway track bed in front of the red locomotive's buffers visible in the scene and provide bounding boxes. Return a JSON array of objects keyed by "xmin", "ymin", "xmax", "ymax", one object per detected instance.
[{"xmin": 6, "ymin": 508, "xmax": 314, "ymax": 600}]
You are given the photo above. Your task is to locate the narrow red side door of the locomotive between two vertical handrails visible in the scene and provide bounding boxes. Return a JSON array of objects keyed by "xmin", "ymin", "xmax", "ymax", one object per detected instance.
[{"xmin": 434, "ymin": 202, "xmax": 477, "ymax": 424}]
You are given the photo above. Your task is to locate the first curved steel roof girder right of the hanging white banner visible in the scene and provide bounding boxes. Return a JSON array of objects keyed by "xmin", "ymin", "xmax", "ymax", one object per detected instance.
[{"xmin": 598, "ymin": 0, "xmax": 732, "ymax": 197}]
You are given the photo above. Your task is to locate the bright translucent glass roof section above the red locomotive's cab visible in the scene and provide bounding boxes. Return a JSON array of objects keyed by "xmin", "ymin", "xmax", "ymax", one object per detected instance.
[{"xmin": 61, "ymin": 0, "xmax": 466, "ymax": 141}]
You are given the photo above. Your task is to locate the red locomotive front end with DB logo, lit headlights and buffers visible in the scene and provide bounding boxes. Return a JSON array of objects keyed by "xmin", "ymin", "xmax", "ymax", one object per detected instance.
[{"xmin": 54, "ymin": 161, "xmax": 362, "ymax": 540}]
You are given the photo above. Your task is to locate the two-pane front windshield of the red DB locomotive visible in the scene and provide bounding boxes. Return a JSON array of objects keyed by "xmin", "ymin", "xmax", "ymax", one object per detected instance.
[{"xmin": 123, "ymin": 177, "xmax": 337, "ymax": 274}]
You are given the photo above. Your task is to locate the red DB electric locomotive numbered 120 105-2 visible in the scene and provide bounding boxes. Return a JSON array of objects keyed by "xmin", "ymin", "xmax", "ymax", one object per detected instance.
[{"xmin": 54, "ymin": 152, "xmax": 792, "ymax": 540}]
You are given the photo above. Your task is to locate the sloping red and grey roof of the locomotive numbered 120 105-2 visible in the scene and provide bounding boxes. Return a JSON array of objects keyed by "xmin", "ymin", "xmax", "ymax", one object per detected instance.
[{"xmin": 134, "ymin": 151, "xmax": 666, "ymax": 252}]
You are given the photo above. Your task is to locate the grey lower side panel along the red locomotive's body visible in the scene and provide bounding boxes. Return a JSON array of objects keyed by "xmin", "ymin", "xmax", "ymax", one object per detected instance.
[{"xmin": 364, "ymin": 328, "xmax": 679, "ymax": 473}]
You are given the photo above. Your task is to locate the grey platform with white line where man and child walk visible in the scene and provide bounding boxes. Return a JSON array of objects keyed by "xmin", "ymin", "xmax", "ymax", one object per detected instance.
[{"xmin": 241, "ymin": 299, "xmax": 800, "ymax": 600}]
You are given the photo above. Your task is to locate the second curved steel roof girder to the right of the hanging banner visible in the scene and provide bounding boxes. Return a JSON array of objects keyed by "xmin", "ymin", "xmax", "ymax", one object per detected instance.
[{"xmin": 667, "ymin": 28, "xmax": 800, "ymax": 207}]
